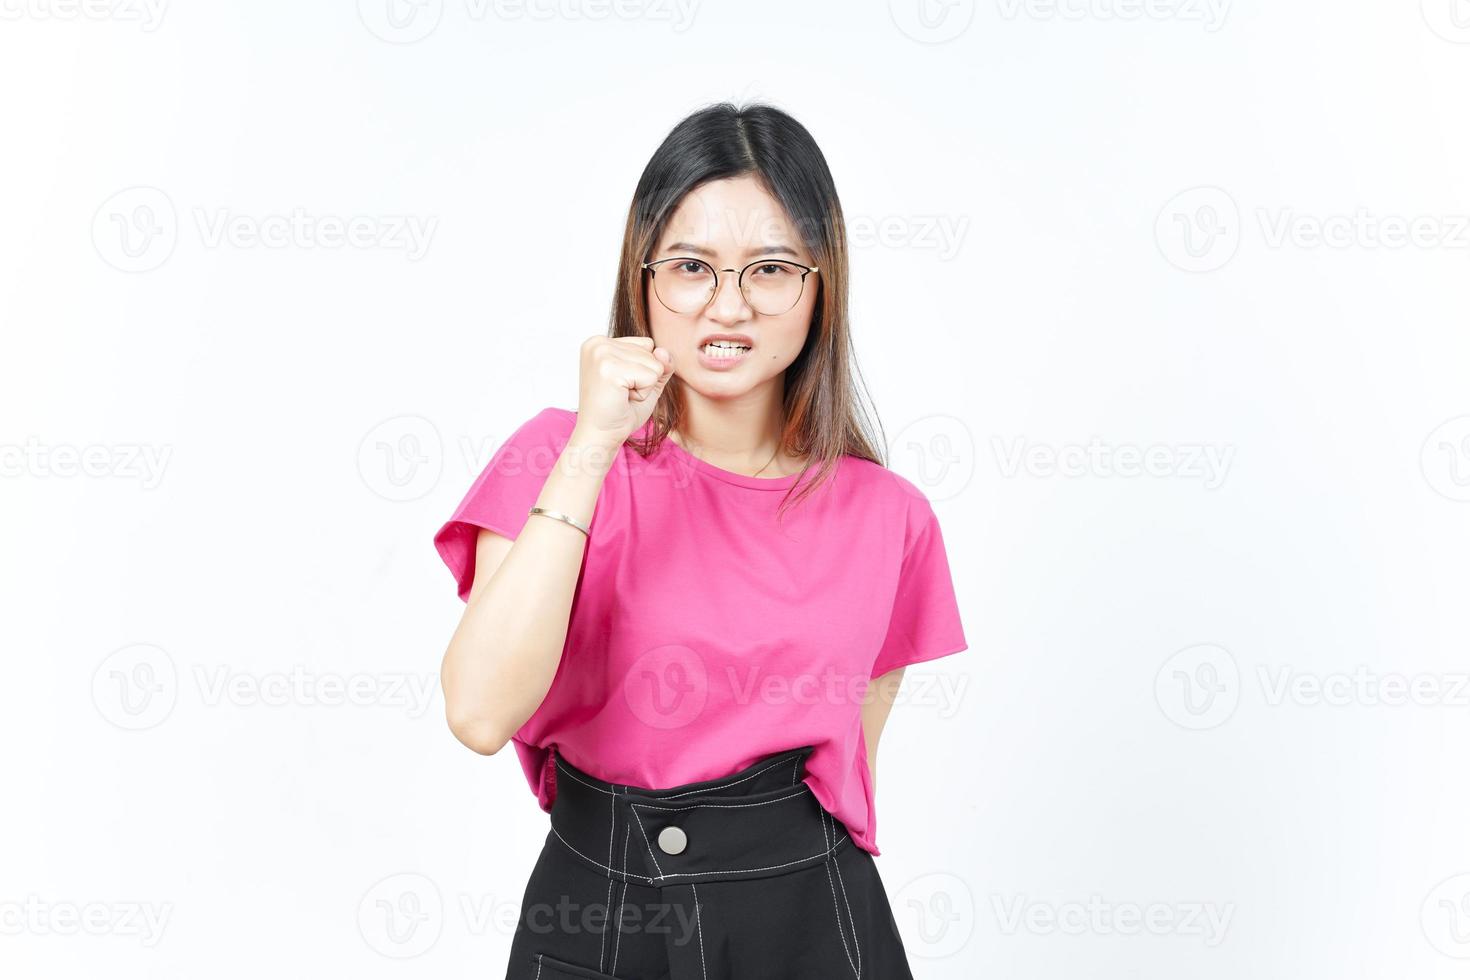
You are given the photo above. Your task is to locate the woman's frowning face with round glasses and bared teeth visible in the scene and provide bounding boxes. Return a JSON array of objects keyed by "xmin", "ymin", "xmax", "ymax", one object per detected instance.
[{"xmin": 644, "ymin": 176, "xmax": 822, "ymax": 398}]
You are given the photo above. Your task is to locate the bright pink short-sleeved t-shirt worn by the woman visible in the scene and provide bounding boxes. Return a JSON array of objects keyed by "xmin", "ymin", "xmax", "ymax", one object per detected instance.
[{"xmin": 434, "ymin": 408, "xmax": 967, "ymax": 854}]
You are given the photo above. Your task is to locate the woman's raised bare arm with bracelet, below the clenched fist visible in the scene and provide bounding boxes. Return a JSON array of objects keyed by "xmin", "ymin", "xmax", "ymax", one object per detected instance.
[{"xmin": 440, "ymin": 425, "xmax": 617, "ymax": 755}]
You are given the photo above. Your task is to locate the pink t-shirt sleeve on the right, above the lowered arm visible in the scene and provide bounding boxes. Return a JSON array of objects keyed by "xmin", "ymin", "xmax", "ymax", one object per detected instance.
[{"xmin": 872, "ymin": 497, "xmax": 969, "ymax": 677}]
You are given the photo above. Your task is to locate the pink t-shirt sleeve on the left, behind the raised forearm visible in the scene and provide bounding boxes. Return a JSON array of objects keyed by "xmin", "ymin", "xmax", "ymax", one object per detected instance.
[{"xmin": 434, "ymin": 408, "xmax": 576, "ymax": 601}]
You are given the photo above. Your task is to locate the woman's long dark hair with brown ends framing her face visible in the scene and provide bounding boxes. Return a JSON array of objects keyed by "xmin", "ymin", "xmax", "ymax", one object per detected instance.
[{"xmin": 609, "ymin": 101, "xmax": 886, "ymax": 516}]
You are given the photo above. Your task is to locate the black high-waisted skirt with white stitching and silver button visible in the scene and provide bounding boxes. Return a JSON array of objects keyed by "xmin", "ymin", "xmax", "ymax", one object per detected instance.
[{"xmin": 506, "ymin": 745, "xmax": 913, "ymax": 980}]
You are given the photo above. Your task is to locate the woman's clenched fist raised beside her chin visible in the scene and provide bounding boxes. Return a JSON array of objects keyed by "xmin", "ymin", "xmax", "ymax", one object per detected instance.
[{"xmin": 576, "ymin": 336, "xmax": 673, "ymax": 447}]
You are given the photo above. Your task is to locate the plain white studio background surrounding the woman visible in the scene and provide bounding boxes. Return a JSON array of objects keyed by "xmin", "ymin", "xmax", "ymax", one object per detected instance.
[{"xmin": 0, "ymin": 0, "xmax": 1470, "ymax": 980}]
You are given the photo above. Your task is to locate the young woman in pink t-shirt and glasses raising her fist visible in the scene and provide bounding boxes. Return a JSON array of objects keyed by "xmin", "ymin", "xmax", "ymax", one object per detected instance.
[{"xmin": 435, "ymin": 103, "xmax": 966, "ymax": 980}]
